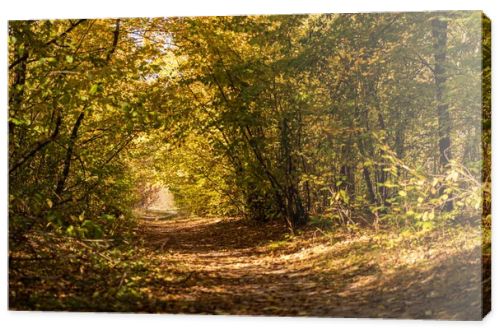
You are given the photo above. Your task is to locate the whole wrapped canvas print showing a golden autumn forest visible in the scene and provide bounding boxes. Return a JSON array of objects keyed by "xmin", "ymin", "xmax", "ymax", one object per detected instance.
[{"xmin": 8, "ymin": 11, "xmax": 491, "ymax": 319}]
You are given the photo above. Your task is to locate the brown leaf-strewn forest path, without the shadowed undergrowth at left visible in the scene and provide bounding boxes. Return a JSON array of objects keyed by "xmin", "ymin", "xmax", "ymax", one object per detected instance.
[{"xmin": 139, "ymin": 216, "xmax": 480, "ymax": 319}]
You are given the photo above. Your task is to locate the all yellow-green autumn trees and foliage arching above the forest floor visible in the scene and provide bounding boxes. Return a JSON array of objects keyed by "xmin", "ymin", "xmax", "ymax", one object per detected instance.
[{"xmin": 9, "ymin": 12, "xmax": 490, "ymax": 316}]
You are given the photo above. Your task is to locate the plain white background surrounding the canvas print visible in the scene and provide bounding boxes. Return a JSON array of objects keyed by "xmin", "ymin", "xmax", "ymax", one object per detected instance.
[{"xmin": 0, "ymin": 0, "xmax": 500, "ymax": 334}]
